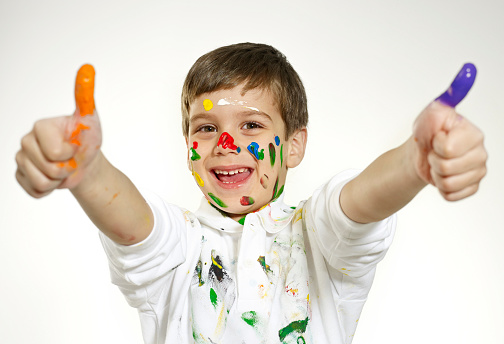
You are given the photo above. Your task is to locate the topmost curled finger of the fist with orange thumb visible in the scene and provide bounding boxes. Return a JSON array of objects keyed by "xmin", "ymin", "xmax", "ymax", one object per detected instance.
[{"xmin": 33, "ymin": 117, "xmax": 75, "ymax": 162}]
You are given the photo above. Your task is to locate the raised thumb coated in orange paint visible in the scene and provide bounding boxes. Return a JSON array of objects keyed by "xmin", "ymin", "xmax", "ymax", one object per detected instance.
[{"xmin": 75, "ymin": 64, "xmax": 95, "ymax": 116}]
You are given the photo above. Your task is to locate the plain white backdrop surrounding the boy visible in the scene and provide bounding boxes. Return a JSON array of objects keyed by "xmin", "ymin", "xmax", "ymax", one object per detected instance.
[{"xmin": 0, "ymin": 0, "xmax": 504, "ymax": 344}]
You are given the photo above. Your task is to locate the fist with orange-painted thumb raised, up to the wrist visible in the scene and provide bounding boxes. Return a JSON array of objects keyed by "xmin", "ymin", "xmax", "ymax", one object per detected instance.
[{"xmin": 16, "ymin": 65, "xmax": 102, "ymax": 198}]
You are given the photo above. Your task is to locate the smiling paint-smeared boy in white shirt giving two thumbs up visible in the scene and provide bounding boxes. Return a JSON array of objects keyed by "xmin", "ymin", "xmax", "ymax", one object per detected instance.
[{"xmin": 16, "ymin": 43, "xmax": 486, "ymax": 344}]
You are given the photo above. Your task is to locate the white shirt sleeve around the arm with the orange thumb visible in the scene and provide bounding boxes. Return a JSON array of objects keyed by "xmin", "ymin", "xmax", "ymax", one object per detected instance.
[{"xmin": 100, "ymin": 194, "xmax": 191, "ymax": 310}]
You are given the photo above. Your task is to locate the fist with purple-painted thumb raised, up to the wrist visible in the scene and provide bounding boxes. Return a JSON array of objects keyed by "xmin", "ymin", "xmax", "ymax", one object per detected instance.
[{"xmin": 413, "ymin": 64, "xmax": 487, "ymax": 201}]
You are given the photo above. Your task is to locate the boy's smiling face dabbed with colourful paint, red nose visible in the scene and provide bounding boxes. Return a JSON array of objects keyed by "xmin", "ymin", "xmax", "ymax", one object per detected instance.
[{"xmin": 187, "ymin": 85, "xmax": 300, "ymax": 219}]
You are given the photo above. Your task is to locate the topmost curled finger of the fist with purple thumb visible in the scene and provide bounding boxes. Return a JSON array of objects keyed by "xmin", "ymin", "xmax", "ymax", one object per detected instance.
[{"xmin": 432, "ymin": 115, "xmax": 484, "ymax": 159}]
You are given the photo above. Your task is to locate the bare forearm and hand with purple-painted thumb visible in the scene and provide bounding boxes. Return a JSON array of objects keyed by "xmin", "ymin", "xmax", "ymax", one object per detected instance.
[{"xmin": 340, "ymin": 65, "xmax": 487, "ymax": 223}]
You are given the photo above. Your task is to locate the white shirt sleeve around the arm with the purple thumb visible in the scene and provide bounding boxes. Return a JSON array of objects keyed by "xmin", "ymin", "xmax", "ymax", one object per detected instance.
[{"xmin": 307, "ymin": 170, "xmax": 396, "ymax": 278}]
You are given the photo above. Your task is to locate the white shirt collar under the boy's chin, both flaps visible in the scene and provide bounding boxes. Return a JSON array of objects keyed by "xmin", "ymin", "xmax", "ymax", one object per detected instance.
[{"xmin": 196, "ymin": 193, "xmax": 295, "ymax": 233}]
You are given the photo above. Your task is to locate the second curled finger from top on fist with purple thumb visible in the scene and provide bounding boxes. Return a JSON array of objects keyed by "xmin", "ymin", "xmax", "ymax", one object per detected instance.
[{"xmin": 427, "ymin": 146, "xmax": 488, "ymax": 177}]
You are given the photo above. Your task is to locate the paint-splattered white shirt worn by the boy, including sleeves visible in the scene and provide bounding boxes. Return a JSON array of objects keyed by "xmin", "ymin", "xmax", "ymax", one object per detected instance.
[{"xmin": 101, "ymin": 171, "xmax": 396, "ymax": 344}]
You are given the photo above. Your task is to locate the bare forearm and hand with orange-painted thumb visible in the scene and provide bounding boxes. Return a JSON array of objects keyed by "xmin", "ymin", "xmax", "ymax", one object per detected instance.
[{"xmin": 16, "ymin": 65, "xmax": 154, "ymax": 245}]
